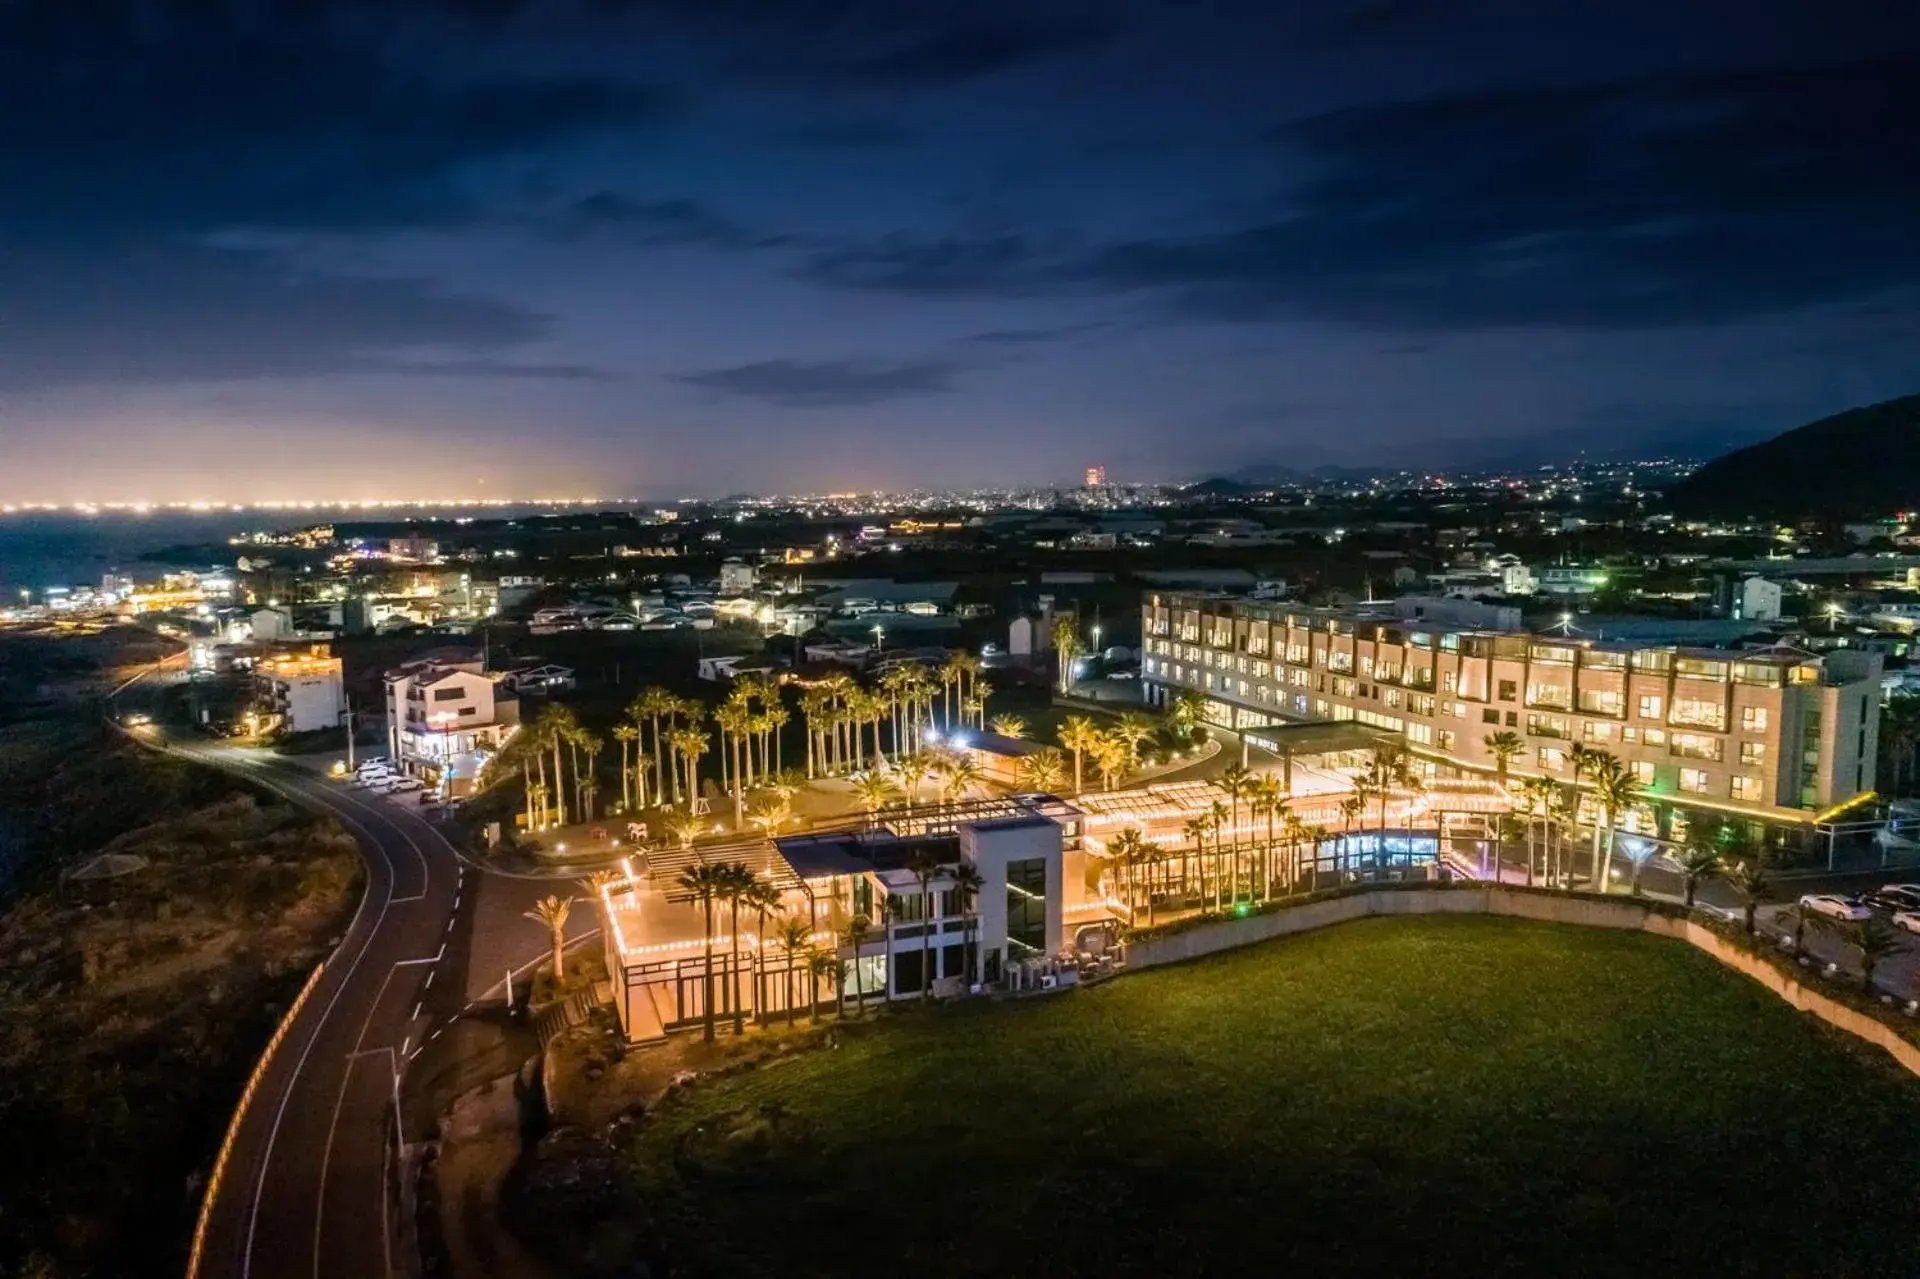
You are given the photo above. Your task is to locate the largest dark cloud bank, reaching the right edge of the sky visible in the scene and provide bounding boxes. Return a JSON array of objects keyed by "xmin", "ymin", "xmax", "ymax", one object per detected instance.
[{"xmin": 803, "ymin": 58, "xmax": 1920, "ymax": 328}]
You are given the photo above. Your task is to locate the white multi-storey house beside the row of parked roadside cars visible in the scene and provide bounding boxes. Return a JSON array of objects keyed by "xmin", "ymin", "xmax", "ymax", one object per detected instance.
[{"xmin": 384, "ymin": 655, "xmax": 520, "ymax": 795}]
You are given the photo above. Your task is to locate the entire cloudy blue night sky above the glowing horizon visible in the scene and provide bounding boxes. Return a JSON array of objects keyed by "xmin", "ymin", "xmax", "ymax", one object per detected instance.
[{"xmin": 0, "ymin": 0, "xmax": 1920, "ymax": 499}]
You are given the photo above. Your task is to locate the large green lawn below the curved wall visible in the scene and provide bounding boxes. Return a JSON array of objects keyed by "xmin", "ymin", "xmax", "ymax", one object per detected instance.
[{"xmin": 636, "ymin": 918, "xmax": 1920, "ymax": 1275}]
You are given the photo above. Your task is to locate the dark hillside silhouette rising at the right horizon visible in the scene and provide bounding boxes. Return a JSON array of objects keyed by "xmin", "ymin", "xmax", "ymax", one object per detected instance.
[{"xmin": 1668, "ymin": 396, "xmax": 1920, "ymax": 519}]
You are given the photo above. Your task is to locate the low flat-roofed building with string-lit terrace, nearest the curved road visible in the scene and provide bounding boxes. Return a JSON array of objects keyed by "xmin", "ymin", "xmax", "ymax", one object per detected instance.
[{"xmin": 601, "ymin": 795, "xmax": 1116, "ymax": 1041}]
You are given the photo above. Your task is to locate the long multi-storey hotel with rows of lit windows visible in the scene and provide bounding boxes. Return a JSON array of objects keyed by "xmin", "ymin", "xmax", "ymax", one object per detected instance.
[{"xmin": 1140, "ymin": 593, "xmax": 1880, "ymax": 833}]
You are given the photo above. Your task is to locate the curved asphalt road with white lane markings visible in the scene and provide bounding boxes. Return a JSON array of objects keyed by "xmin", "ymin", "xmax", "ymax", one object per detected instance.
[{"xmin": 115, "ymin": 668, "xmax": 597, "ymax": 1279}]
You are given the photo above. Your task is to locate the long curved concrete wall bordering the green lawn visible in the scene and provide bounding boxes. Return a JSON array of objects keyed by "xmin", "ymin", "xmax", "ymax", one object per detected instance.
[{"xmin": 1127, "ymin": 887, "xmax": 1920, "ymax": 1075}]
